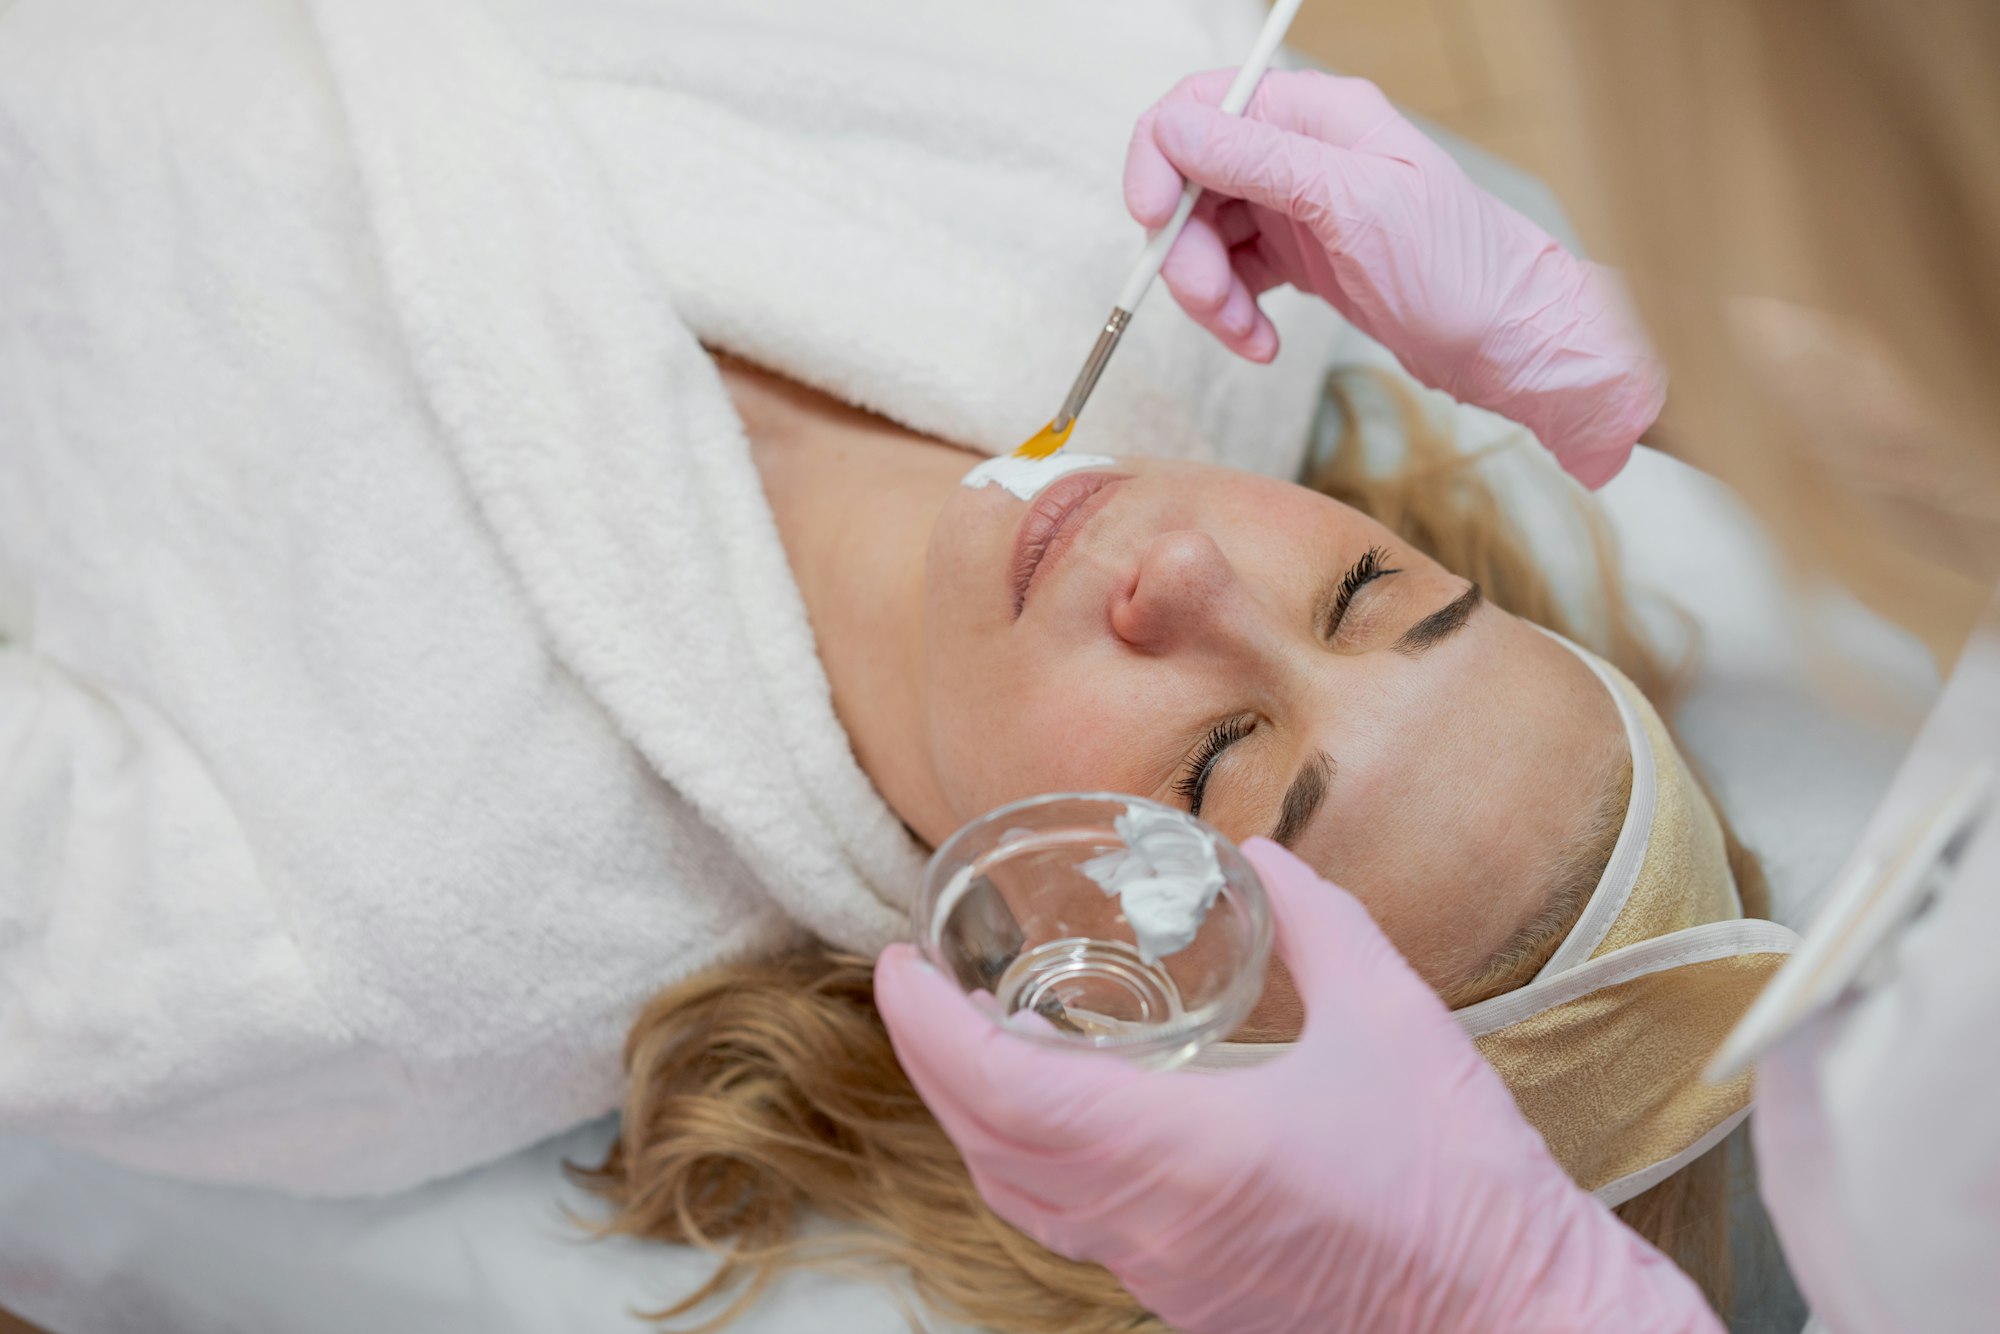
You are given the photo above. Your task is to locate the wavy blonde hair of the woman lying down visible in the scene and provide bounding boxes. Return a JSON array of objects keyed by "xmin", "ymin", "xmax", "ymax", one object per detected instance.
[{"xmin": 572, "ymin": 380, "xmax": 1762, "ymax": 1334}]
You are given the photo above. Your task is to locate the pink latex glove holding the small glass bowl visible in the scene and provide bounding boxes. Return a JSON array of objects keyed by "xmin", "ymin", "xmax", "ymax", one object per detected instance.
[{"xmin": 876, "ymin": 838, "xmax": 1722, "ymax": 1334}]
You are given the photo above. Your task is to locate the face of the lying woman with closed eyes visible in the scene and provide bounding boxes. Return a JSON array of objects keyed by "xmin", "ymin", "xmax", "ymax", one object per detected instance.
[{"xmin": 920, "ymin": 460, "xmax": 1622, "ymax": 986}]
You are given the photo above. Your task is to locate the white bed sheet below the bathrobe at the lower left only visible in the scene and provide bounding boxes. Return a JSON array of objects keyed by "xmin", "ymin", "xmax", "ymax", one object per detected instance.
[{"xmin": 0, "ymin": 1120, "xmax": 976, "ymax": 1334}]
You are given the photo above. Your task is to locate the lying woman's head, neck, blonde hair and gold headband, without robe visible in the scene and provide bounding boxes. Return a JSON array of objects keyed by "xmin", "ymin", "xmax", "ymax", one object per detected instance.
[{"xmin": 582, "ymin": 360, "xmax": 1764, "ymax": 1330}]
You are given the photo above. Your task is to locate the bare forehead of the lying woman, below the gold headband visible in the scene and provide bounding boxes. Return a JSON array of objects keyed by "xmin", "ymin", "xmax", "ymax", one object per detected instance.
[{"xmin": 1300, "ymin": 608, "xmax": 1624, "ymax": 982}]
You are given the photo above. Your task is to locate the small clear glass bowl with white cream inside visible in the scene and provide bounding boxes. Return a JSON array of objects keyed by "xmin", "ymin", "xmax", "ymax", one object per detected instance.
[{"xmin": 912, "ymin": 792, "xmax": 1272, "ymax": 1068}]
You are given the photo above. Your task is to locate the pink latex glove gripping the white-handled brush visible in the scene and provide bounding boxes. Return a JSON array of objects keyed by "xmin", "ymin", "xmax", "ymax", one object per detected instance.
[{"xmin": 1124, "ymin": 70, "xmax": 1666, "ymax": 486}]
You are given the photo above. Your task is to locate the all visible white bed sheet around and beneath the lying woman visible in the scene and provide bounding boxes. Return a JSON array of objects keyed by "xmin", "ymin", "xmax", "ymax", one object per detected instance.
[{"xmin": 0, "ymin": 109, "xmax": 1936, "ymax": 1334}]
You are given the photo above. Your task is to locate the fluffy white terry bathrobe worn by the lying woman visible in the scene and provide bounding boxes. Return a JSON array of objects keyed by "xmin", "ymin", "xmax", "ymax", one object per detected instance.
[{"xmin": 0, "ymin": 0, "xmax": 1342, "ymax": 1192}]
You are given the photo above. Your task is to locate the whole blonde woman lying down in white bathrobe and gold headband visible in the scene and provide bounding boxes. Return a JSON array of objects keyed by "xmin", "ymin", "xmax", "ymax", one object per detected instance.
[{"xmin": 0, "ymin": 0, "xmax": 1762, "ymax": 1330}]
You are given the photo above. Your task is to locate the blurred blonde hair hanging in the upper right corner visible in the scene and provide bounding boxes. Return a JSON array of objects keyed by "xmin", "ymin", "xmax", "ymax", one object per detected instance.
[{"xmin": 1554, "ymin": 0, "xmax": 2000, "ymax": 656}]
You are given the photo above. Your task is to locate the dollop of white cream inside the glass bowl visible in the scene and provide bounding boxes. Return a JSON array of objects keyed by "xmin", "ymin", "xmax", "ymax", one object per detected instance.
[{"xmin": 1082, "ymin": 806, "xmax": 1222, "ymax": 964}]
